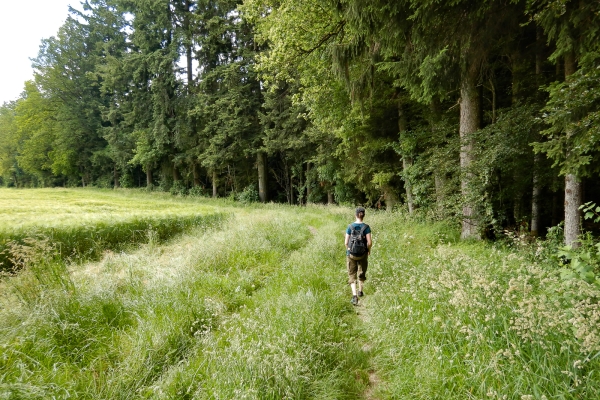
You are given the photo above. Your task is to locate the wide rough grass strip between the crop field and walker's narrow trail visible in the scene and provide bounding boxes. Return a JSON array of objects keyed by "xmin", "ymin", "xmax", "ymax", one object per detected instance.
[{"xmin": 0, "ymin": 206, "xmax": 376, "ymax": 399}]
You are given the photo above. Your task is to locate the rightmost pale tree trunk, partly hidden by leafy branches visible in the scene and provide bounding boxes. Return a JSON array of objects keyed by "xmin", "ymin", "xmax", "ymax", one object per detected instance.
[{"xmin": 565, "ymin": 51, "xmax": 582, "ymax": 248}]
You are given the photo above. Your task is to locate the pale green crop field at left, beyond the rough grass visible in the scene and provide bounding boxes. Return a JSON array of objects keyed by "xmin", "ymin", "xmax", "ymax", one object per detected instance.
[{"xmin": 0, "ymin": 189, "xmax": 226, "ymax": 271}]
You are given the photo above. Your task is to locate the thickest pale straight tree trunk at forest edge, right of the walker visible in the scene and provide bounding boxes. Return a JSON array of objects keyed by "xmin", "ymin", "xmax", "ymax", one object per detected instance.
[{"xmin": 459, "ymin": 55, "xmax": 480, "ymax": 239}]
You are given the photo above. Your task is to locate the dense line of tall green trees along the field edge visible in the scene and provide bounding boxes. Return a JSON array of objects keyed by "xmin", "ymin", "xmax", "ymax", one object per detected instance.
[{"xmin": 0, "ymin": 0, "xmax": 600, "ymax": 243}]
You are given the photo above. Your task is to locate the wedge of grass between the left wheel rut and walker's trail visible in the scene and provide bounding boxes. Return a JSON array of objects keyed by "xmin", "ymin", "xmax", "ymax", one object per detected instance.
[{"xmin": 150, "ymin": 211, "xmax": 367, "ymax": 399}]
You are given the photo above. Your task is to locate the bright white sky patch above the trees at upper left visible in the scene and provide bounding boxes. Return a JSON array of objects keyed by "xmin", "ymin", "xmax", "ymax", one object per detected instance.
[{"xmin": 0, "ymin": 0, "xmax": 79, "ymax": 105}]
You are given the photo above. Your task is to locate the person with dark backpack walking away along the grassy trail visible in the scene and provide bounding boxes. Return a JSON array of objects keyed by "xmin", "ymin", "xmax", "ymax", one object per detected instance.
[{"xmin": 344, "ymin": 207, "xmax": 373, "ymax": 306}]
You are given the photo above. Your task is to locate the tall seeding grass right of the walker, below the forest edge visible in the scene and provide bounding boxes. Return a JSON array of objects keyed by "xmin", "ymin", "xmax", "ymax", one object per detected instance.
[{"xmin": 365, "ymin": 217, "xmax": 600, "ymax": 400}]
